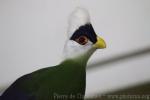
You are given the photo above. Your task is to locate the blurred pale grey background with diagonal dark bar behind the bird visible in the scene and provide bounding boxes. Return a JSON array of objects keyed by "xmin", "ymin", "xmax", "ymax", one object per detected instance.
[{"xmin": 0, "ymin": 0, "xmax": 150, "ymax": 100}]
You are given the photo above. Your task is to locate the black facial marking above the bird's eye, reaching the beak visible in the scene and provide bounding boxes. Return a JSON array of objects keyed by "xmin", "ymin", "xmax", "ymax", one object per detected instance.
[{"xmin": 70, "ymin": 24, "xmax": 97, "ymax": 43}]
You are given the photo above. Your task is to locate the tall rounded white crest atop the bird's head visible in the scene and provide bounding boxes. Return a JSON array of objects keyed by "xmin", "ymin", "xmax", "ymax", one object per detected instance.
[{"xmin": 68, "ymin": 7, "xmax": 90, "ymax": 37}]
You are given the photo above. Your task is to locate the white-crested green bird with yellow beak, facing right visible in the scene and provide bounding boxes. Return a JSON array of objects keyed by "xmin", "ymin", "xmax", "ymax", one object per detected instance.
[{"xmin": 0, "ymin": 7, "xmax": 106, "ymax": 100}]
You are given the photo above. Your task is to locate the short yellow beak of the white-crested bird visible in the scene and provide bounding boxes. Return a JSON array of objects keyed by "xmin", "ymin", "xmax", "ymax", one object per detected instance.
[{"xmin": 94, "ymin": 37, "xmax": 106, "ymax": 49}]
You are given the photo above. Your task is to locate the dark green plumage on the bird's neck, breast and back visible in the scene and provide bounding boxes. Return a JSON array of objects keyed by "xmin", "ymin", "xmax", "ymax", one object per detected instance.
[{"xmin": 4, "ymin": 60, "xmax": 86, "ymax": 100}]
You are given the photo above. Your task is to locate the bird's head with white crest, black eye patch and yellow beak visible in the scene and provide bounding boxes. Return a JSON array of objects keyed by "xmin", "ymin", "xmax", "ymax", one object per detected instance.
[{"xmin": 64, "ymin": 8, "xmax": 106, "ymax": 63}]
